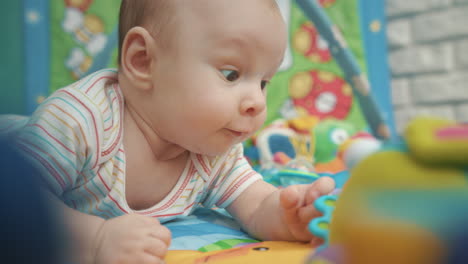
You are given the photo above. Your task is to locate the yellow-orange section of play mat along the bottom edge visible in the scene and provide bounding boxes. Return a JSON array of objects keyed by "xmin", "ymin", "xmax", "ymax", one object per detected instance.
[{"xmin": 165, "ymin": 241, "xmax": 312, "ymax": 264}]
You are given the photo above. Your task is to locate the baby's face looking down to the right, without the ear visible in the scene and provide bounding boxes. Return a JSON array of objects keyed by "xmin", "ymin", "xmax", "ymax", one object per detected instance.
[{"xmin": 147, "ymin": 0, "xmax": 287, "ymax": 155}]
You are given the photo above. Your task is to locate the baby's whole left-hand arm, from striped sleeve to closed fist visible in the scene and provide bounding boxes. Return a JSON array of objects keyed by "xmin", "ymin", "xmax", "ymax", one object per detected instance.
[{"xmin": 12, "ymin": 86, "xmax": 170, "ymax": 264}]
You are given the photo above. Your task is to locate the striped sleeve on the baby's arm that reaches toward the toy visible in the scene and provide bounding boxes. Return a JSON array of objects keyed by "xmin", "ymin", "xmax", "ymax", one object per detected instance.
[{"xmin": 203, "ymin": 144, "xmax": 262, "ymax": 208}]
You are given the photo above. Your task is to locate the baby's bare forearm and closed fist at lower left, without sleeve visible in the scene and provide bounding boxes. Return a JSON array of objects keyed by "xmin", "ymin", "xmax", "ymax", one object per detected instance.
[{"xmin": 45, "ymin": 194, "xmax": 171, "ymax": 264}]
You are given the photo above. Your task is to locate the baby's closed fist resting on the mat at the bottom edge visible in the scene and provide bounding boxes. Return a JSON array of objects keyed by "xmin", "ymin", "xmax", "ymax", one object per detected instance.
[{"xmin": 94, "ymin": 214, "xmax": 171, "ymax": 264}]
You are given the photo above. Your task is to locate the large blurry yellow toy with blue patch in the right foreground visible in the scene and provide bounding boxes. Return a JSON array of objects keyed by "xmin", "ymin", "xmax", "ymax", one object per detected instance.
[{"xmin": 308, "ymin": 118, "xmax": 468, "ymax": 264}]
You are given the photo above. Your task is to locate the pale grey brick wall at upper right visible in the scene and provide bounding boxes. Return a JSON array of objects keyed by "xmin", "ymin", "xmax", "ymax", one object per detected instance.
[{"xmin": 386, "ymin": 0, "xmax": 468, "ymax": 131}]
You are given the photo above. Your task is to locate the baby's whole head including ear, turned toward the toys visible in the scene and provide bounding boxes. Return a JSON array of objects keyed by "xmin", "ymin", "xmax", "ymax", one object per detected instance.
[{"xmin": 119, "ymin": 0, "xmax": 287, "ymax": 155}]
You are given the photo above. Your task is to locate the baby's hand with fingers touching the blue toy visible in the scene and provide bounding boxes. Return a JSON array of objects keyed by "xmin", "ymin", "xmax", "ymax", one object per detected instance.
[{"xmin": 280, "ymin": 177, "xmax": 335, "ymax": 246}]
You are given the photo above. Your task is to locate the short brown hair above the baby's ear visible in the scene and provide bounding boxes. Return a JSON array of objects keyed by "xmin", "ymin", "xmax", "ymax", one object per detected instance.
[{"xmin": 118, "ymin": 0, "xmax": 174, "ymax": 65}]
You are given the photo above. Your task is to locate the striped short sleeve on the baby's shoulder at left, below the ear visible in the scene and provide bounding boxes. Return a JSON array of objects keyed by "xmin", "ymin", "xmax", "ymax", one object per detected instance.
[{"xmin": 14, "ymin": 88, "xmax": 100, "ymax": 197}]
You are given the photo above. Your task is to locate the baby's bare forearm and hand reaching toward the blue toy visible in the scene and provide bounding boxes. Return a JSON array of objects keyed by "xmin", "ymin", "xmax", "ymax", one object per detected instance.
[{"xmin": 227, "ymin": 177, "xmax": 335, "ymax": 241}]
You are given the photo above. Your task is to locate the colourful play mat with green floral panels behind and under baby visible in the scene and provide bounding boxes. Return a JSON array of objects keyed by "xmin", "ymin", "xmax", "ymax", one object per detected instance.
[{"xmin": 0, "ymin": 0, "xmax": 394, "ymax": 263}]
